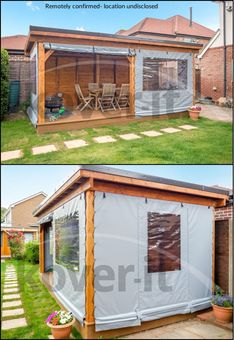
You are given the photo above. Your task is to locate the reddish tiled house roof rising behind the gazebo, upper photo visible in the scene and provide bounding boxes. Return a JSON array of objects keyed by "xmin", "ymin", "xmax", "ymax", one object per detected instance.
[{"xmin": 116, "ymin": 15, "xmax": 215, "ymax": 38}]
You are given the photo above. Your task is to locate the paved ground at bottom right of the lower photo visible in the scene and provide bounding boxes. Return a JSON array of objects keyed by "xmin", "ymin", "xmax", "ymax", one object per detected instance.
[{"xmin": 121, "ymin": 318, "xmax": 233, "ymax": 339}]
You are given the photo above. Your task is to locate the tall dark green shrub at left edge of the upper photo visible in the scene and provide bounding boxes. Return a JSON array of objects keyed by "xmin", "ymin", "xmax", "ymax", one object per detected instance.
[{"xmin": 1, "ymin": 49, "xmax": 9, "ymax": 119}]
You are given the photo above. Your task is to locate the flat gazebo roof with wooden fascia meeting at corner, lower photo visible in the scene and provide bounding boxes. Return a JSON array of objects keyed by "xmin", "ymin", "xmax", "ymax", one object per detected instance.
[{"xmin": 34, "ymin": 165, "xmax": 229, "ymax": 216}]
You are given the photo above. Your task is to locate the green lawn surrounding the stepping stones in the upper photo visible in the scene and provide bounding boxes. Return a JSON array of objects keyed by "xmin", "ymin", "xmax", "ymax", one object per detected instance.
[{"xmin": 2, "ymin": 113, "xmax": 232, "ymax": 164}]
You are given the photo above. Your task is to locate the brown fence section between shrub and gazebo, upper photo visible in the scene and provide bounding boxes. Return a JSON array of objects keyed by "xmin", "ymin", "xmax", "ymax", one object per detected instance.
[{"xmin": 9, "ymin": 55, "xmax": 30, "ymax": 103}]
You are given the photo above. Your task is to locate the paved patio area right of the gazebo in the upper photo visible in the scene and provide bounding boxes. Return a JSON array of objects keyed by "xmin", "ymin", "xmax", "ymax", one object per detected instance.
[{"xmin": 198, "ymin": 104, "xmax": 233, "ymax": 122}]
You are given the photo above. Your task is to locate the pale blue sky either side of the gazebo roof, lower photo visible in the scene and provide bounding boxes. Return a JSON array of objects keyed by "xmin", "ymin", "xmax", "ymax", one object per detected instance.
[{"xmin": 1, "ymin": 165, "xmax": 232, "ymax": 208}]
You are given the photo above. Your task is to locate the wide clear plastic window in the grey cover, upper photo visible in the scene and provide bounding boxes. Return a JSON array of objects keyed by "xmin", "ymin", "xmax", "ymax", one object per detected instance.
[{"xmin": 143, "ymin": 58, "xmax": 188, "ymax": 91}]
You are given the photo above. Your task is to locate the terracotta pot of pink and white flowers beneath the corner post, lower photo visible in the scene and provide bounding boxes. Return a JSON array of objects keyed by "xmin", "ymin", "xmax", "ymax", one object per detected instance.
[{"xmin": 46, "ymin": 310, "xmax": 75, "ymax": 339}]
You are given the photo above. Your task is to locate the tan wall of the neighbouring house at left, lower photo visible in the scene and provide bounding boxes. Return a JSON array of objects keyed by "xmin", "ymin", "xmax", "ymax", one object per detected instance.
[{"xmin": 11, "ymin": 194, "xmax": 45, "ymax": 227}]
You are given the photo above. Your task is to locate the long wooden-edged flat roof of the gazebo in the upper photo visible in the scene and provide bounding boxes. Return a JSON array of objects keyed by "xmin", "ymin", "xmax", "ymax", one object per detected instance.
[{"xmin": 25, "ymin": 26, "xmax": 203, "ymax": 53}]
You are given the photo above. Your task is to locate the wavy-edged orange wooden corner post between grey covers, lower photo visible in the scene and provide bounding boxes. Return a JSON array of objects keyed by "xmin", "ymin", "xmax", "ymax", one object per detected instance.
[{"xmin": 85, "ymin": 190, "xmax": 95, "ymax": 325}]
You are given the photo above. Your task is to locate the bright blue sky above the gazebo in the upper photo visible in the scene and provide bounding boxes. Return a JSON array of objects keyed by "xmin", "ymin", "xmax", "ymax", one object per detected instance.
[{"xmin": 1, "ymin": 0, "xmax": 219, "ymax": 36}]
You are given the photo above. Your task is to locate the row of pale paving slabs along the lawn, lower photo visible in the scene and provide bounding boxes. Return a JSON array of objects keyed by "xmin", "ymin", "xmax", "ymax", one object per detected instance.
[{"xmin": 1, "ymin": 265, "xmax": 27, "ymax": 330}]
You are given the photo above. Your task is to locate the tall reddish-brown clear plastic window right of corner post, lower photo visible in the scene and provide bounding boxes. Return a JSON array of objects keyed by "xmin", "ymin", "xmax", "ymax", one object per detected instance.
[{"xmin": 147, "ymin": 212, "xmax": 181, "ymax": 273}]
